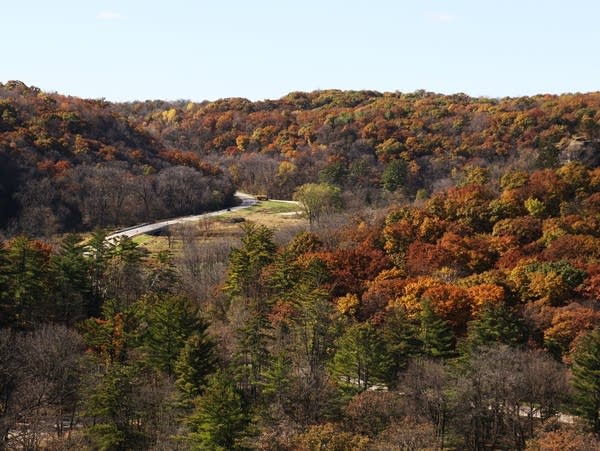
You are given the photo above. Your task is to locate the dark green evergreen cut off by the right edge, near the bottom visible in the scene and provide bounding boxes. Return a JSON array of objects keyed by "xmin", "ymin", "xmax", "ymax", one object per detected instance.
[{"xmin": 573, "ymin": 326, "xmax": 600, "ymax": 433}]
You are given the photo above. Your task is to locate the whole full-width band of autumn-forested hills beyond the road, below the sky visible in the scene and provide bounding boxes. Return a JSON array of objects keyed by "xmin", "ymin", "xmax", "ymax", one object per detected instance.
[{"xmin": 0, "ymin": 82, "xmax": 600, "ymax": 236}]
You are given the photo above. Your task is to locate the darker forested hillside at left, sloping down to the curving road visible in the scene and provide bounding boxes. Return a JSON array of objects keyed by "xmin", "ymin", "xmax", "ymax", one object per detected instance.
[{"xmin": 0, "ymin": 82, "xmax": 234, "ymax": 236}]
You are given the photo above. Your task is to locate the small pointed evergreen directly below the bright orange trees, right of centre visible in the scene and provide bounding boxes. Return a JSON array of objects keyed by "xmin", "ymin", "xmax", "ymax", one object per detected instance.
[{"xmin": 419, "ymin": 299, "xmax": 454, "ymax": 357}]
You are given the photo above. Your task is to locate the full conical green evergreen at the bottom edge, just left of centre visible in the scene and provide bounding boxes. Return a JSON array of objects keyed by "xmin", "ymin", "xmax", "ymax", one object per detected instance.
[{"xmin": 188, "ymin": 371, "xmax": 250, "ymax": 451}]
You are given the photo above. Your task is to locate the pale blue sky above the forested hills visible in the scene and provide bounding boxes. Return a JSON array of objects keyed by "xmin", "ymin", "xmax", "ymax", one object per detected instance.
[{"xmin": 0, "ymin": 0, "xmax": 600, "ymax": 101}]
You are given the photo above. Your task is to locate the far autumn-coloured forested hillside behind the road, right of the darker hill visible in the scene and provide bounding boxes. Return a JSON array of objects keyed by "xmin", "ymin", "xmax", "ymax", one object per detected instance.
[{"xmin": 118, "ymin": 91, "xmax": 600, "ymax": 201}]
